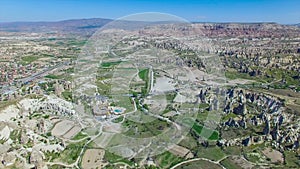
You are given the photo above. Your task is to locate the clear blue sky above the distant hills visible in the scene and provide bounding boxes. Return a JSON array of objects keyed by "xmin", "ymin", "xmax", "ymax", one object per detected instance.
[{"xmin": 0, "ymin": 0, "xmax": 300, "ymax": 24}]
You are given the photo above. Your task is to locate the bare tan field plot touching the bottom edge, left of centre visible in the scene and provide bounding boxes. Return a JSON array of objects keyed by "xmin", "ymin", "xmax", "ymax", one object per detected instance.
[{"xmin": 82, "ymin": 149, "xmax": 105, "ymax": 169}]
